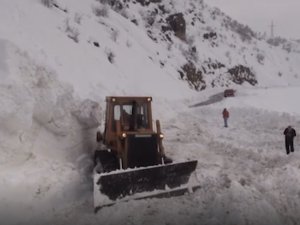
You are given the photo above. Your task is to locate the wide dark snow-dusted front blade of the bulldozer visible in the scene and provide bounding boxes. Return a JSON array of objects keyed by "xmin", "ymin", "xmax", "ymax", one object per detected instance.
[{"xmin": 94, "ymin": 160, "xmax": 199, "ymax": 212}]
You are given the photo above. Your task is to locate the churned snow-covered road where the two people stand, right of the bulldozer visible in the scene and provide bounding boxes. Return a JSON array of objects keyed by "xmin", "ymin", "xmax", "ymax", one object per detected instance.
[{"xmin": 13, "ymin": 89, "xmax": 300, "ymax": 225}]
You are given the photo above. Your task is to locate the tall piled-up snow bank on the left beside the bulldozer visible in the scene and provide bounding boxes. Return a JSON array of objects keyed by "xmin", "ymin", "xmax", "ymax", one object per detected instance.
[{"xmin": 0, "ymin": 40, "xmax": 102, "ymax": 224}]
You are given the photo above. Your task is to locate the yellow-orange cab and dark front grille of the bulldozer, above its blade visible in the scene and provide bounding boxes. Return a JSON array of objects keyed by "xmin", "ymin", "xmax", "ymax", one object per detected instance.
[{"xmin": 103, "ymin": 96, "xmax": 159, "ymax": 169}]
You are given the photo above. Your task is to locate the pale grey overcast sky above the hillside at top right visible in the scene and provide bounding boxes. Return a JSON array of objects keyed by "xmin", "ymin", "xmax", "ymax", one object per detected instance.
[{"xmin": 206, "ymin": 0, "xmax": 300, "ymax": 39}]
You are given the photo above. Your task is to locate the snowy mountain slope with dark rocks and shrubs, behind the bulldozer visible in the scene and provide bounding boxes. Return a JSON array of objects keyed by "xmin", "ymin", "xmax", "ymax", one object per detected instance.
[{"xmin": 1, "ymin": 0, "xmax": 299, "ymax": 98}]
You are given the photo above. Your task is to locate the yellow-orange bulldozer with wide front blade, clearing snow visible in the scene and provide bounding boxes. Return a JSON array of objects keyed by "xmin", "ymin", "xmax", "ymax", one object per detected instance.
[{"xmin": 93, "ymin": 96, "xmax": 199, "ymax": 212}]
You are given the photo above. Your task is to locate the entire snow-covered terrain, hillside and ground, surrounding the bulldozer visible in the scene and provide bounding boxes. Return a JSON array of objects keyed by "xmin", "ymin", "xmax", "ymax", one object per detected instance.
[{"xmin": 0, "ymin": 0, "xmax": 300, "ymax": 225}]
